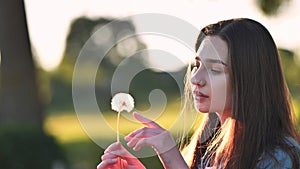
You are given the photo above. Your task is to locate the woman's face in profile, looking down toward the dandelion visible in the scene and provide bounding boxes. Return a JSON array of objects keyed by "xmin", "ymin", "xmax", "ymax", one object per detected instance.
[{"xmin": 191, "ymin": 36, "xmax": 232, "ymax": 113}]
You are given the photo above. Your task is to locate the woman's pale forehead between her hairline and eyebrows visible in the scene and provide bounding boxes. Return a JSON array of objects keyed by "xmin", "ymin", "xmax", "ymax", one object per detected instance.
[{"xmin": 196, "ymin": 36, "xmax": 228, "ymax": 63}]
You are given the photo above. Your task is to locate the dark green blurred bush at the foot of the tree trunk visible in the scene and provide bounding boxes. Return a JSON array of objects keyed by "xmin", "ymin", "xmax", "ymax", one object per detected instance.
[{"xmin": 0, "ymin": 125, "xmax": 68, "ymax": 169}]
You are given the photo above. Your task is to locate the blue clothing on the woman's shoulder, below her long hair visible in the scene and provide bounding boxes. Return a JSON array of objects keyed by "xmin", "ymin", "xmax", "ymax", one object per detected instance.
[{"xmin": 257, "ymin": 137, "xmax": 300, "ymax": 169}]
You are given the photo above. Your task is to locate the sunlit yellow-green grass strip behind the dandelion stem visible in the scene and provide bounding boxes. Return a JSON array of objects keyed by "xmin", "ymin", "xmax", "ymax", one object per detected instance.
[{"xmin": 45, "ymin": 102, "xmax": 190, "ymax": 143}]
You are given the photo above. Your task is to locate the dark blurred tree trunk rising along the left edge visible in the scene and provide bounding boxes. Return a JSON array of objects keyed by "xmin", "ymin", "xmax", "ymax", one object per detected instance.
[{"xmin": 0, "ymin": 0, "xmax": 43, "ymax": 125}]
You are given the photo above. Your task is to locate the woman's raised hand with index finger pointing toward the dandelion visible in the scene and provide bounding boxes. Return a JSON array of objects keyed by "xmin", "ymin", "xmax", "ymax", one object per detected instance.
[{"xmin": 125, "ymin": 112, "xmax": 189, "ymax": 169}]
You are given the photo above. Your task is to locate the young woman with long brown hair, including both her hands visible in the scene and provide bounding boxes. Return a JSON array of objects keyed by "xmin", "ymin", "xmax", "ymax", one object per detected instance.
[{"xmin": 97, "ymin": 18, "xmax": 300, "ymax": 169}]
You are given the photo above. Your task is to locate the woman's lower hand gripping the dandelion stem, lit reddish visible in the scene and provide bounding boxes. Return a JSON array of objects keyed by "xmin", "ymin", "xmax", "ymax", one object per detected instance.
[{"xmin": 97, "ymin": 142, "xmax": 145, "ymax": 169}]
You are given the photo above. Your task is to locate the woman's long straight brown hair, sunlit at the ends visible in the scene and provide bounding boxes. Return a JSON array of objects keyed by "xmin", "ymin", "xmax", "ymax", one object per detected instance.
[{"xmin": 182, "ymin": 18, "xmax": 300, "ymax": 169}]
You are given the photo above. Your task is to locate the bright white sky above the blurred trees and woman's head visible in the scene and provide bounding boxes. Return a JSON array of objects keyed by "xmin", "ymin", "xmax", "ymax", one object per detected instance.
[{"xmin": 25, "ymin": 0, "xmax": 300, "ymax": 71}]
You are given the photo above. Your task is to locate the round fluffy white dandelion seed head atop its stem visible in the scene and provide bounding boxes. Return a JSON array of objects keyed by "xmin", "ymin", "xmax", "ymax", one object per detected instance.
[{"xmin": 111, "ymin": 93, "xmax": 134, "ymax": 112}]
